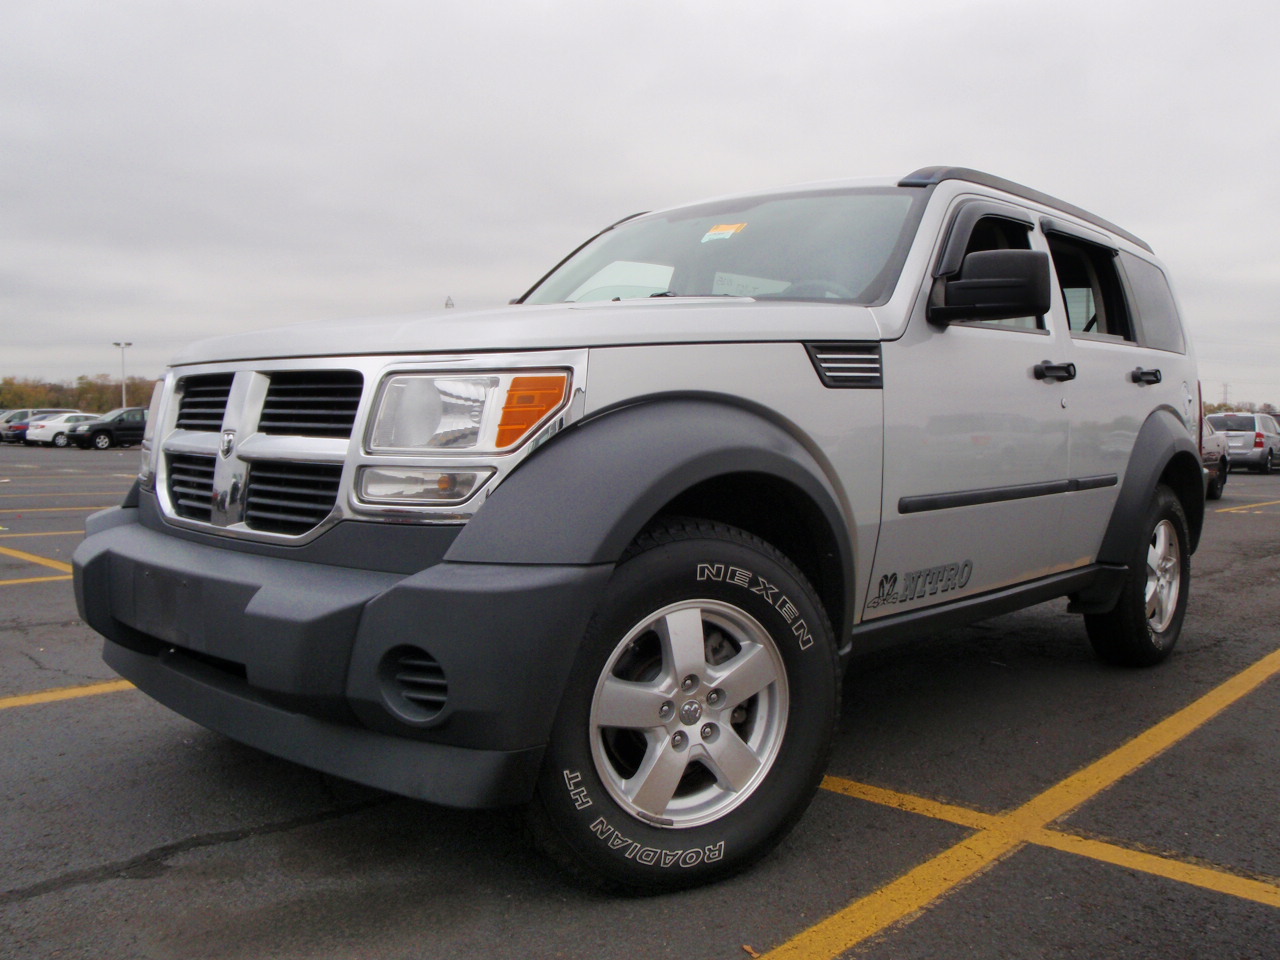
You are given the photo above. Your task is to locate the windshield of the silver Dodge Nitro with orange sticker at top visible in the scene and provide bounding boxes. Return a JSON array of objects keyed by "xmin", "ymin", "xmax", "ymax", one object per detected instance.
[{"xmin": 522, "ymin": 188, "xmax": 925, "ymax": 306}]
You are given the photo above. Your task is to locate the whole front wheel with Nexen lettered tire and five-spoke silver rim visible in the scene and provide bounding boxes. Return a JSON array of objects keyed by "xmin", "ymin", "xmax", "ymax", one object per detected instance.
[{"xmin": 530, "ymin": 520, "xmax": 840, "ymax": 892}]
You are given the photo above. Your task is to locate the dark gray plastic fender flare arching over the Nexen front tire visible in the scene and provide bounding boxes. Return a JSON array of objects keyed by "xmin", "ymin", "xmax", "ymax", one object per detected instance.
[{"xmin": 445, "ymin": 398, "xmax": 852, "ymax": 582}]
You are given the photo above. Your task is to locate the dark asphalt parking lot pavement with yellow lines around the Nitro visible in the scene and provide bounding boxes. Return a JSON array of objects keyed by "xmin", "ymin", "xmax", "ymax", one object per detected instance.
[{"xmin": 0, "ymin": 445, "xmax": 1280, "ymax": 960}]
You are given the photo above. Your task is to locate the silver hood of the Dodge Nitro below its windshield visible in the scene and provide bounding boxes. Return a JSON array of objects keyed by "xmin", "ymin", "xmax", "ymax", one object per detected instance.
[{"xmin": 173, "ymin": 297, "xmax": 881, "ymax": 366}]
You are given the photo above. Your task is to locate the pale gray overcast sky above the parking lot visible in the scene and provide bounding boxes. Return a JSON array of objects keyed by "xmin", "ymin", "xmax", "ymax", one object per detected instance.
[{"xmin": 0, "ymin": 0, "xmax": 1280, "ymax": 404}]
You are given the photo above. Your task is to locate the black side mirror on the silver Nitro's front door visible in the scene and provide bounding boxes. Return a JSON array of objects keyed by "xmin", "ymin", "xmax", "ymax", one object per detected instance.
[{"xmin": 928, "ymin": 250, "xmax": 1050, "ymax": 324}]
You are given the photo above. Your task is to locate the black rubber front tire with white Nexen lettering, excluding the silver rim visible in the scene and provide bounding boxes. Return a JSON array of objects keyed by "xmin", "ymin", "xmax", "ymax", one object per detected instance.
[{"xmin": 539, "ymin": 531, "xmax": 838, "ymax": 890}]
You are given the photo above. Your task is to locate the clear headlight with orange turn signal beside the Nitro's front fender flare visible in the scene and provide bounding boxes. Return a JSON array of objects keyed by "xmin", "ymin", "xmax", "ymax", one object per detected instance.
[{"xmin": 366, "ymin": 370, "xmax": 570, "ymax": 454}]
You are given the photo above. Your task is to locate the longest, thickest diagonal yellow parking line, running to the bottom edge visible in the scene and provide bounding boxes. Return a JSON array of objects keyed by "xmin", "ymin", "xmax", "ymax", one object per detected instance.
[{"xmin": 767, "ymin": 650, "xmax": 1280, "ymax": 960}]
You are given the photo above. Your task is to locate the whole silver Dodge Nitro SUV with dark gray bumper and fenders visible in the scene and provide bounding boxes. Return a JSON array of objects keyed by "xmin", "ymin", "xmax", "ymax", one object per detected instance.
[{"xmin": 76, "ymin": 168, "xmax": 1204, "ymax": 891}]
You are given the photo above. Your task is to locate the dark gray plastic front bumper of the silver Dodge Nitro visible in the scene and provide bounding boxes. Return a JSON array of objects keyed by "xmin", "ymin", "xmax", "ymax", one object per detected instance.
[{"xmin": 74, "ymin": 508, "xmax": 612, "ymax": 806}]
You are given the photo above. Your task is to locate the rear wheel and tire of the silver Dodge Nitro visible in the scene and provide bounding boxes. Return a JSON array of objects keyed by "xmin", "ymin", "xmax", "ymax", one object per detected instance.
[{"xmin": 1084, "ymin": 485, "xmax": 1192, "ymax": 667}]
